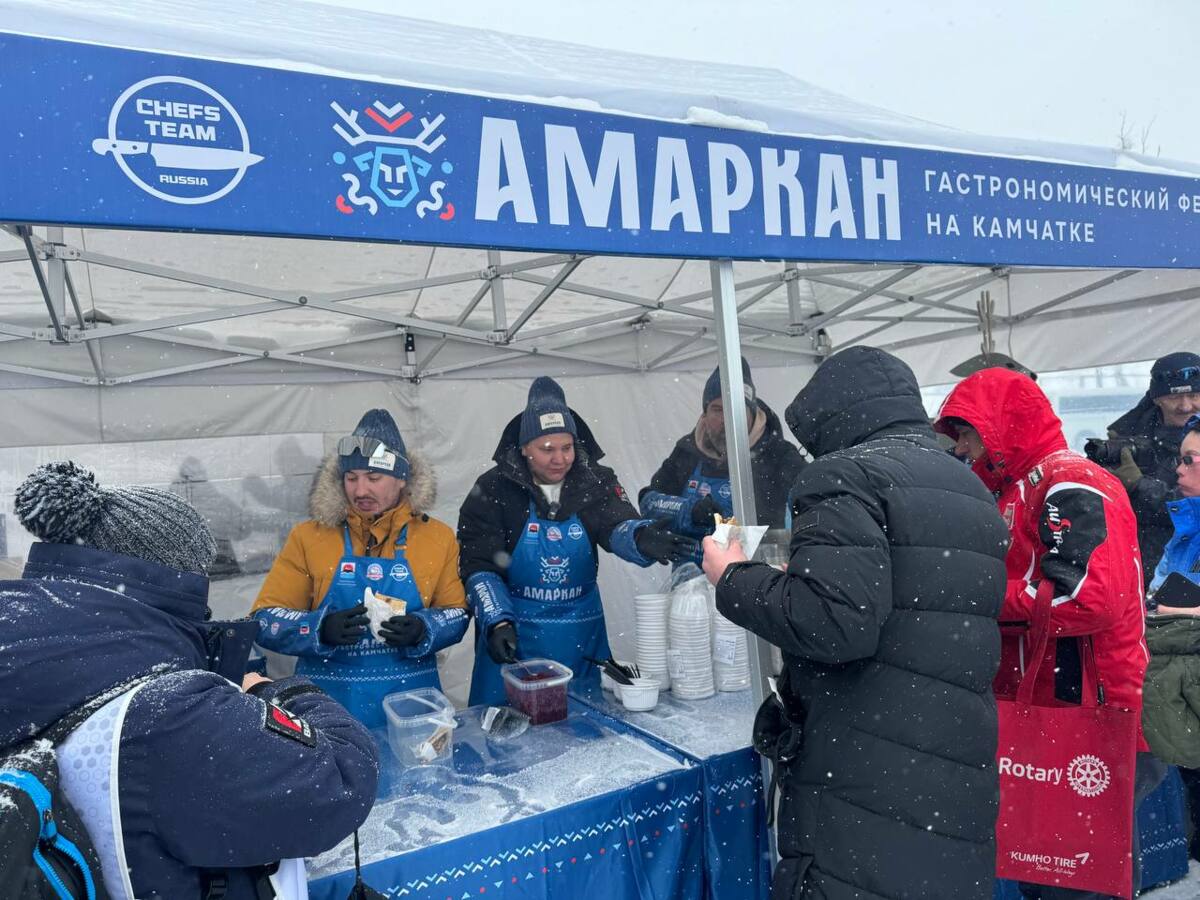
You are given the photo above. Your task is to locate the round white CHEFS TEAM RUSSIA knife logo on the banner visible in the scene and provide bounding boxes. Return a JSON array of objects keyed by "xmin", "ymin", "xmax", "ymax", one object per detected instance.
[{"xmin": 91, "ymin": 76, "xmax": 263, "ymax": 204}]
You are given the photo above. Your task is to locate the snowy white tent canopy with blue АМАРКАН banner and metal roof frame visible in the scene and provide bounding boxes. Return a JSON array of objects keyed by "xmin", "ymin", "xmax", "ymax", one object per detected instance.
[{"xmin": 0, "ymin": 0, "xmax": 1200, "ymax": 400}]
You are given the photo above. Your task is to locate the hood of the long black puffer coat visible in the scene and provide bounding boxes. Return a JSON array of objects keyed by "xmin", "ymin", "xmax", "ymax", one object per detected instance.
[{"xmin": 786, "ymin": 347, "xmax": 932, "ymax": 456}]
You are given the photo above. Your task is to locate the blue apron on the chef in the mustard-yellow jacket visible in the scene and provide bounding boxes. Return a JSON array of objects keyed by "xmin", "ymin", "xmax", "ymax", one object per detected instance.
[{"xmin": 296, "ymin": 526, "xmax": 442, "ymax": 728}]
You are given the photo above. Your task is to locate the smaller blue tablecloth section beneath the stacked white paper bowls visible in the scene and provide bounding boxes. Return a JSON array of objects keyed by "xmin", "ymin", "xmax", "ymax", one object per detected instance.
[{"xmin": 577, "ymin": 690, "xmax": 770, "ymax": 900}]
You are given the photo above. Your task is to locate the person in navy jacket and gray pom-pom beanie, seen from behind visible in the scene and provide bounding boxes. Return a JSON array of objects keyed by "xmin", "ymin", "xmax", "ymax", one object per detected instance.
[{"xmin": 0, "ymin": 462, "xmax": 378, "ymax": 900}]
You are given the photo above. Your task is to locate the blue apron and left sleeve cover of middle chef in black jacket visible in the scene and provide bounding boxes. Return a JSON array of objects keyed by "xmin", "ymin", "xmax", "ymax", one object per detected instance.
[{"xmin": 470, "ymin": 500, "xmax": 611, "ymax": 706}]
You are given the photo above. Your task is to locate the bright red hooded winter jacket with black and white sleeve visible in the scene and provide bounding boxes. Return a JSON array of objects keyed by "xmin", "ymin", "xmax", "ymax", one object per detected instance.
[{"xmin": 935, "ymin": 368, "xmax": 1150, "ymax": 750}]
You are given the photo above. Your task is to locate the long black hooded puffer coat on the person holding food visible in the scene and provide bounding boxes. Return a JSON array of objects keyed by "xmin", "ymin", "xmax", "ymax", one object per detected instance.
[{"xmin": 716, "ymin": 347, "xmax": 1008, "ymax": 900}]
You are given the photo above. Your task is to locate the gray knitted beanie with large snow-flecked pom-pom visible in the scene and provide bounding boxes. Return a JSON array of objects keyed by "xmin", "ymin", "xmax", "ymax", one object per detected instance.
[{"xmin": 14, "ymin": 462, "xmax": 217, "ymax": 575}]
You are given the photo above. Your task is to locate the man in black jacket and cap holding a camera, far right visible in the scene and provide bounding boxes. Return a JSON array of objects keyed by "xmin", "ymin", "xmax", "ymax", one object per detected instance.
[{"xmin": 1099, "ymin": 352, "xmax": 1200, "ymax": 584}]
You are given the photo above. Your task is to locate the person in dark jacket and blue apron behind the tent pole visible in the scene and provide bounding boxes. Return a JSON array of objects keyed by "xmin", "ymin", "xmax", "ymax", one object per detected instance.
[{"xmin": 637, "ymin": 359, "xmax": 806, "ymax": 549}]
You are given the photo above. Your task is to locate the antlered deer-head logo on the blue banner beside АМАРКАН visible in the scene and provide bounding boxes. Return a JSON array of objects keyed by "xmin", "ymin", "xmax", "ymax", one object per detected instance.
[{"xmin": 329, "ymin": 100, "xmax": 455, "ymax": 222}]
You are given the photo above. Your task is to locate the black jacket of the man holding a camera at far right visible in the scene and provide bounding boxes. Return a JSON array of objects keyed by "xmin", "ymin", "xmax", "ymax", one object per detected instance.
[{"xmin": 1109, "ymin": 396, "xmax": 1183, "ymax": 584}]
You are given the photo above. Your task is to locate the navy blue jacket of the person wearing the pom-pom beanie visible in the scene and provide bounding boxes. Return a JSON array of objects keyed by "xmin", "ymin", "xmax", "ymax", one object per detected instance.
[{"xmin": 0, "ymin": 544, "xmax": 378, "ymax": 900}]
